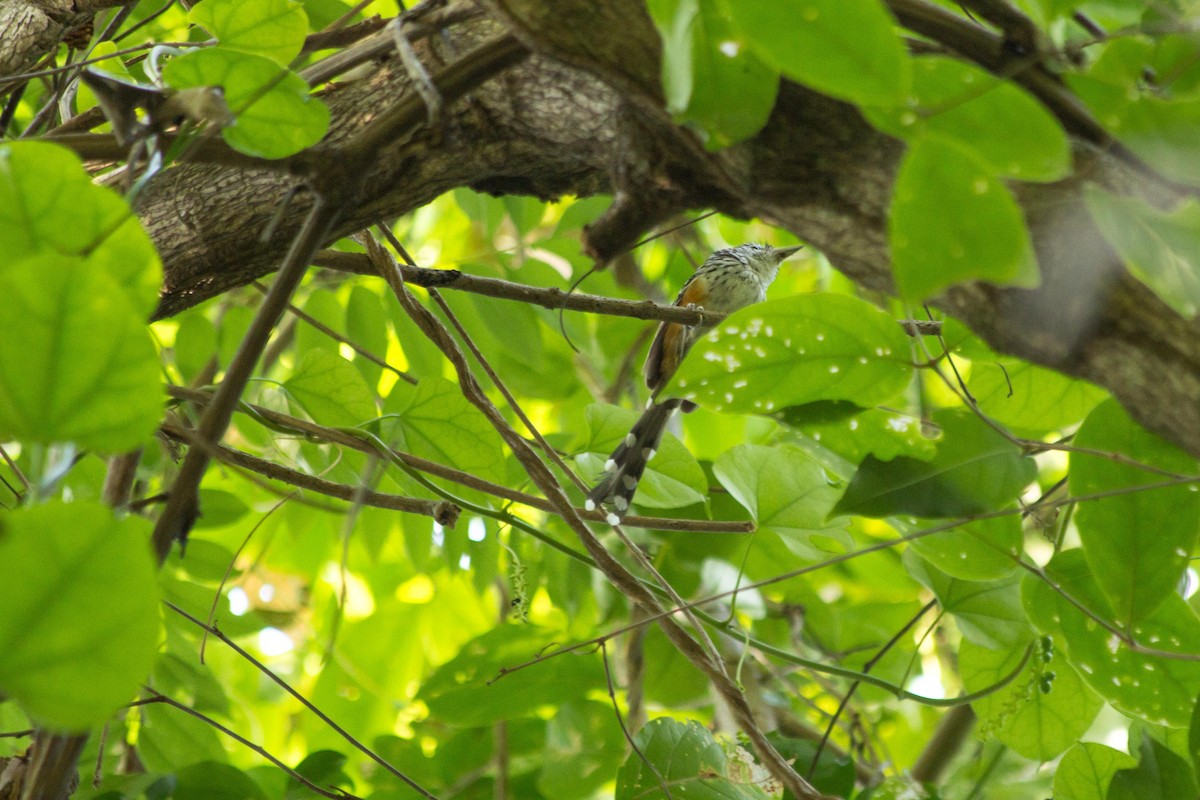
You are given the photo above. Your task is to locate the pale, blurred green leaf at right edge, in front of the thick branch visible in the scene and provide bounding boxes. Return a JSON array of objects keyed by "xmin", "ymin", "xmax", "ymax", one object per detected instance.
[{"xmin": 1084, "ymin": 186, "xmax": 1200, "ymax": 317}]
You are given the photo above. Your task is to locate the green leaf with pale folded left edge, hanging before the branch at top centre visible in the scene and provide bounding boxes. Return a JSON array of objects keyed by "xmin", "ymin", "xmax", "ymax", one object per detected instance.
[{"xmin": 650, "ymin": 0, "xmax": 779, "ymax": 150}]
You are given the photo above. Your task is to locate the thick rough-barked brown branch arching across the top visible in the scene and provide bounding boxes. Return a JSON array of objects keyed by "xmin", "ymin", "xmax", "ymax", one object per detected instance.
[{"xmin": 100, "ymin": 0, "xmax": 1200, "ymax": 456}]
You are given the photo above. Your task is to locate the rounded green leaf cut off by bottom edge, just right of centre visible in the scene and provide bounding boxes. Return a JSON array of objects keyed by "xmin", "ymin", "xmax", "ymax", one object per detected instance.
[{"xmin": 614, "ymin": 717, "xmax": 768, "ymax": 800}]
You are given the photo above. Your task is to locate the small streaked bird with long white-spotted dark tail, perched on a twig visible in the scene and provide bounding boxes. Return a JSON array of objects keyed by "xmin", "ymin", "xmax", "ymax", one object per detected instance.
[{"xmin": 584, "ymin": 243, "xmax": 803, "ymax": 525}]
